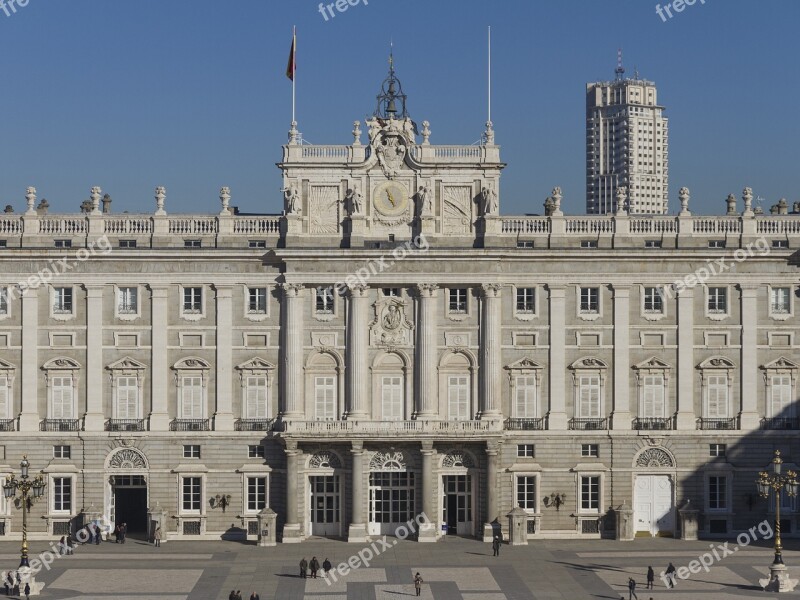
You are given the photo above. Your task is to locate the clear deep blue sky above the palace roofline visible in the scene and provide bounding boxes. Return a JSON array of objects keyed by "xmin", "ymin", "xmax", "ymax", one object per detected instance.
[{"xmin": 0, "ymin": 0, "xmax": 800, "ymax": 214}]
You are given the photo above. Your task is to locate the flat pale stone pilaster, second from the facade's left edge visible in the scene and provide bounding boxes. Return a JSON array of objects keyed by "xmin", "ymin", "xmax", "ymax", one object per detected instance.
[{"xmin": 83, "ymin": 285, "xmax": 104, "ymax": 431}]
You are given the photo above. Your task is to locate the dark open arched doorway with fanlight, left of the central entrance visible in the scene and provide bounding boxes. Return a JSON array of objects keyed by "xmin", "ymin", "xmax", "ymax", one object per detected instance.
[{"xmin": 106, "ymin": 448, "xmax": 149, "ymax": 538}]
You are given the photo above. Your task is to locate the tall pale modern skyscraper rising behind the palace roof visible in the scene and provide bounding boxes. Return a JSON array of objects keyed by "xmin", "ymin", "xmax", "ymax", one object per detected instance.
[{"xmin": 586, "ymin": 53, "xmax": 669, "ymax": 214}]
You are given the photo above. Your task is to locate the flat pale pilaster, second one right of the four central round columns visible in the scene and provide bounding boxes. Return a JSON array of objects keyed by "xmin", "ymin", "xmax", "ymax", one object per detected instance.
[{"xmin": 611, "ymin": 284, "xmax": 631, "ymax": 431}]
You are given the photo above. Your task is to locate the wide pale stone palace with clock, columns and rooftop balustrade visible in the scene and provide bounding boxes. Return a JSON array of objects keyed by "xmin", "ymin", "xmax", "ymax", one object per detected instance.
[{"xmin": 0, "ymin": 67, "xmax": 800, "ymax": 542}]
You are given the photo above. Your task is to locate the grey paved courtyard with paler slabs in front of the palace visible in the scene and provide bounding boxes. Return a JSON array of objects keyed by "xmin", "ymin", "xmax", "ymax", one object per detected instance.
[{"xmin": 0, "ymin": 538, "xmax": 800, "ymax": 600}]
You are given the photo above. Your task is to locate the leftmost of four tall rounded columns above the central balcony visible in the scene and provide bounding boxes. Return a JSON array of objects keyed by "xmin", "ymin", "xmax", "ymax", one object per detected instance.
[{"xmin": 281, "ymin": 283, "xmax": 305, "ymax": 419}]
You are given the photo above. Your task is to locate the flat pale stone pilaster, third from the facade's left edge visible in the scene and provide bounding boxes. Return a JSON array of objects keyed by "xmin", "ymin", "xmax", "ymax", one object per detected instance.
[{"xmin": 150, "ymin": 285, "xmax": 170, "ymax": 431}]
